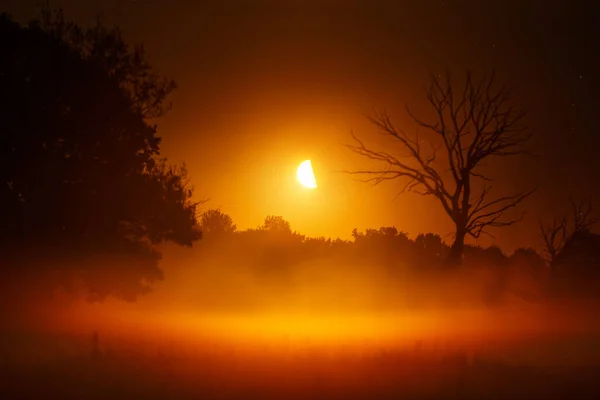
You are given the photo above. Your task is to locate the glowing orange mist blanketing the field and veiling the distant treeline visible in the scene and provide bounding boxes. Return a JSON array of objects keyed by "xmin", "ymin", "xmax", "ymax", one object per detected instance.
[{"xmin": 1, "ymin": 222, "xmax": 600, "ymax": 399}]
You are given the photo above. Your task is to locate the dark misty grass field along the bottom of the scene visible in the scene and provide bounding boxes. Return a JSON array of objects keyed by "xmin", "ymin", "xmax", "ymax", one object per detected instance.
[{"xmin": 0, "ymin": 322, "xmax": 600, "ymax": 399}]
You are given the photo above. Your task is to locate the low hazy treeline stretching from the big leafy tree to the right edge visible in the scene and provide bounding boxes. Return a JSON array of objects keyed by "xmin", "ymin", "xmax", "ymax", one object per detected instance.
[{"xmin": 193, "ymin": 209, "xmax": 600, "ymax": 301}]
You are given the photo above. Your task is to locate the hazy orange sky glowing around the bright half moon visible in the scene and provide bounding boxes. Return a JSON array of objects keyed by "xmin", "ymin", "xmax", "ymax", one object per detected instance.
[{"xmin": 0, "ymin": 0, "xmax": 600, "ymax": 249}]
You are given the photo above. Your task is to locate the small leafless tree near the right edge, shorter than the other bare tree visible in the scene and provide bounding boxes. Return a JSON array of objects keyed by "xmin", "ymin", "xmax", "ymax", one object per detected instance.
[{"xmin": 540, "ymin": 199, "xmax": 600, "ymax": 265}]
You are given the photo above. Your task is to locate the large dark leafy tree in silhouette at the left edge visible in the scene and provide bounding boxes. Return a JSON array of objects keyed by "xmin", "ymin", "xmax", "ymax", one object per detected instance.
[{"xmin": 0, "ymin": 9, "xmax": 200, "ymax": 299}]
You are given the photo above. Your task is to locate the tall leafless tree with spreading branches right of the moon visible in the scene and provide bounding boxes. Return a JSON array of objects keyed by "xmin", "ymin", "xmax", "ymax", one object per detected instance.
[{"xmin": 348, "ymin": 71, "xmax": 533, "ymax": 264}]
